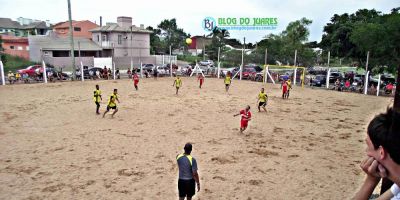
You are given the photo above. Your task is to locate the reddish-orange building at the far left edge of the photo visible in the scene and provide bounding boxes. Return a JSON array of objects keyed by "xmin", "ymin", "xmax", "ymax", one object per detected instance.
[{"xmin": 0, "ymin": 35, "xmax": 29, "ymax": 60}]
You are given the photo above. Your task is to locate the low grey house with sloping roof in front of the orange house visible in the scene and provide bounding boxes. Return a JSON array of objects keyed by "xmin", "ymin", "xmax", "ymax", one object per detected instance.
[{"xmin": 28, "ymin": 34, "xmax": 103, "ymax": 67}]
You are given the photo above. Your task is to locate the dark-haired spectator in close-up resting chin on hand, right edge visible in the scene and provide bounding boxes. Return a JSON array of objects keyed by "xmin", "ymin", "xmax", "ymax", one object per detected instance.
[{"xmin": 353, "ymin": 108, "xmax": 400, "ymax": 200}]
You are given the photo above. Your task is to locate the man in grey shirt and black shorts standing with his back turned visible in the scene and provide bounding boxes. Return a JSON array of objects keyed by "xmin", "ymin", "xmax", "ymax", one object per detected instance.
[{"xmin": 176, "ymin": 143, "xmax": 200, "ymax": 200}]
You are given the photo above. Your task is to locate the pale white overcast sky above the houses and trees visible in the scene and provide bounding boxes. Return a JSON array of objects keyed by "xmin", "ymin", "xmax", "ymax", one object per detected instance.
[{"xmin": 0, "ymin": 0, "xmax": 400, "ymax": 43}]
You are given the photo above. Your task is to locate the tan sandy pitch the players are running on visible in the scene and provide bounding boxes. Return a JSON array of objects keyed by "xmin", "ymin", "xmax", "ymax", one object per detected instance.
[{"xmin": 0, "ymin": 78, "xmax": 392, "ymax": 200}]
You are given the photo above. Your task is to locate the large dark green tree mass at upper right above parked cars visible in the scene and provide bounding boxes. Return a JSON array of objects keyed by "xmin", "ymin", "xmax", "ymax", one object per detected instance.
[{"xmin": 319, "ymin": 8, "xmax": 400, "ymax": 73}]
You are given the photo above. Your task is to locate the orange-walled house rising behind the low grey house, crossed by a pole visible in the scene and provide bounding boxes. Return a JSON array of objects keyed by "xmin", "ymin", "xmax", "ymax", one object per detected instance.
[{"xmin": 53, "ymin": 20, "xmax": 98, "ymax": 39}]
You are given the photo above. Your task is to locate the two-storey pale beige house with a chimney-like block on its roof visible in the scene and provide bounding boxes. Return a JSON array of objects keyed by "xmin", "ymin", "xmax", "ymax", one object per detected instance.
[{"xmin": 90, "ymin": 17, "xmax": 152, "ymax": 59}]
